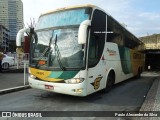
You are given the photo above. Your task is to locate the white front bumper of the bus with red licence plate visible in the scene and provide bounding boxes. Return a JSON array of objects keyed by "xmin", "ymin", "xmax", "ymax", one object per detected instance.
[{"xmin": 28, "ymin": 77, "xmax": 87, "ymax": 96}]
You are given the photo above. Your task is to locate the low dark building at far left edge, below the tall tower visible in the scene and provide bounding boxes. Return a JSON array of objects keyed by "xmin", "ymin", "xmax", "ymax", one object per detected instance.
[{"xmin": 0, "ymin": 25, "xmax": 10, "ymax": 51}]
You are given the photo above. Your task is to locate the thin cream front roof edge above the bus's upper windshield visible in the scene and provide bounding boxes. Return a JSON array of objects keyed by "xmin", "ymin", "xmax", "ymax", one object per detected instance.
[{"xmin": 40, "ymin": 4, "xmax": 97, "ymax": 16}]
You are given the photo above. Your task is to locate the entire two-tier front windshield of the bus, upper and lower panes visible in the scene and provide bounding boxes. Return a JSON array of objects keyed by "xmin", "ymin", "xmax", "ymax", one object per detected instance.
[{"xmin": 30, "ymin": 8, "xmax": 91, "ymax": 70}]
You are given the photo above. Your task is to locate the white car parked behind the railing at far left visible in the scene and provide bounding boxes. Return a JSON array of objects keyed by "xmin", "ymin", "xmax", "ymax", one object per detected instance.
[{"xmin": 2, "ymin": 54, "xmax": 14, "ymax": 69}]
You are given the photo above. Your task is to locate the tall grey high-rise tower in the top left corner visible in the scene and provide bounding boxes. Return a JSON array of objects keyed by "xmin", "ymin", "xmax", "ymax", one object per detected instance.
[{"xmin": 0, "ymin": 0, "xmax": 23, "ymax": 51}]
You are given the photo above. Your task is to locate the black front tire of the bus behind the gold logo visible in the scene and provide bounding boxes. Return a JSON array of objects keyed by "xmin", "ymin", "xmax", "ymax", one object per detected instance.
[{"xmin": 105, "ymin": 71, "xmax": 115, "ymax": 92}]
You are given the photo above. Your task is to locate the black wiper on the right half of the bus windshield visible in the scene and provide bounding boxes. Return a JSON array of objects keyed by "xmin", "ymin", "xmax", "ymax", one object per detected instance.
[{"xmin": 54, "ymin": 35, "xmax": 65, "ymax": 71}]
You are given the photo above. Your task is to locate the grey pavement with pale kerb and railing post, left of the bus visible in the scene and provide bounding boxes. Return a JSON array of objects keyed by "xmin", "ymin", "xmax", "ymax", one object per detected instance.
[{"xmin": 0, "ymin": 66, "xmax": 30, "ymax": 95}]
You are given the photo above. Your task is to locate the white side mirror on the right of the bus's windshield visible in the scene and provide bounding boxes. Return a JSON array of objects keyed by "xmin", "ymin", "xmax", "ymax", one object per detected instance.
[{"xmin": 78, "ymin": 20, "xmax": 91, "ymax": 44}]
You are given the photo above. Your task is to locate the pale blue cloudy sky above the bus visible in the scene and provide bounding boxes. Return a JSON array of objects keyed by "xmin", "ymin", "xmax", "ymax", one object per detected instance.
[{"xmin": 22, "ymin": 0, "xmax": 160, "ymax": 37}]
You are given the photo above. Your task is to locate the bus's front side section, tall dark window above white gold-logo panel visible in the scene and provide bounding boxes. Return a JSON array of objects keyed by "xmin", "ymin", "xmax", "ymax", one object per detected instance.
[{"xmin": 87, "ymin": 10, "xmax": 106, "ymax": 94}]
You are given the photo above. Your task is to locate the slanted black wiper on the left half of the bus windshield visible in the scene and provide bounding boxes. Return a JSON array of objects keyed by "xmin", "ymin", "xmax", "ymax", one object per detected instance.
[{"xmin": 35, "ymin": 31, "xmax": 54, "ymax": 68}]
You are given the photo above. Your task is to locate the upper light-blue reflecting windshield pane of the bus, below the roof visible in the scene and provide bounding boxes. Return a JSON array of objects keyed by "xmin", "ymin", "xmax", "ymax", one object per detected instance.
[{"xmin": 35, "ymin": 8, "xmax": 91, "ymax": 29}]
